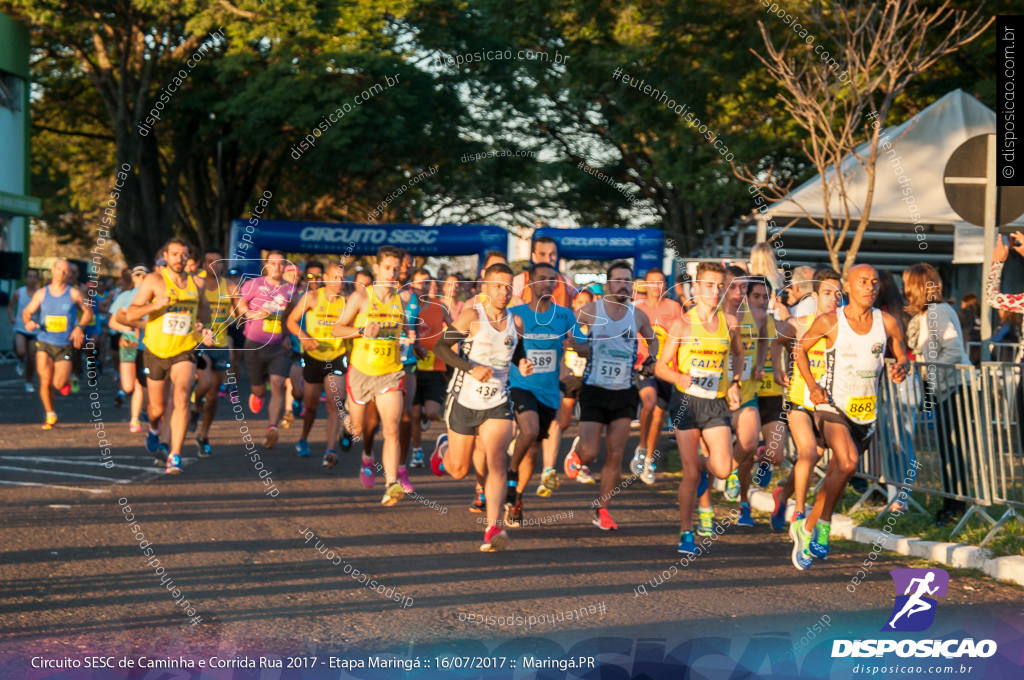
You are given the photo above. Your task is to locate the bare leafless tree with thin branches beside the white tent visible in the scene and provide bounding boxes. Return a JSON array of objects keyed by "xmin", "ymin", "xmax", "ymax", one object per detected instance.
[{"xmin": 734, "ymin": 0, "xmax": 994, "ymax": 274}]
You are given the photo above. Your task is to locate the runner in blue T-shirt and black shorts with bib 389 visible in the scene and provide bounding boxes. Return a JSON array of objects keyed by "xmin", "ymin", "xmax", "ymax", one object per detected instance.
[{"xmin": 505, "ymin": 262, "xmax": 585, "ymax": 526}]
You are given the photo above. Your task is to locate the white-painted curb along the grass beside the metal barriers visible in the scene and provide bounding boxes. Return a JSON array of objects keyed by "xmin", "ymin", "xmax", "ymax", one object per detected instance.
[{"xmin": 751, "ymin": 490, "xmax": 1024, "ymax": 586}]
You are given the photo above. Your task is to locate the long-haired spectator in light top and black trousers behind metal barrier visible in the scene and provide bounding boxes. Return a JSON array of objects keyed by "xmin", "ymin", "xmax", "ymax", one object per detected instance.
[{"xmin": 903, "ymin": 263, "xmax": 970, "ymax": 526}]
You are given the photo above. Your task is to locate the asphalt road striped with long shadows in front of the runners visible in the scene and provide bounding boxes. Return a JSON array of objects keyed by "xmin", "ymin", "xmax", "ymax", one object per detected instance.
[{"xmin": 0, "ymin": 366, "xmax": 1024, "ymax": 677}]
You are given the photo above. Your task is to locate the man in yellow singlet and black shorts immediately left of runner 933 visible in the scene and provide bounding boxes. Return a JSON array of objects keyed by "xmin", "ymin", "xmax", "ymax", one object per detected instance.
[{"xmin": 288, "ymin": 260, "xmax": 346, "ymax": 468}]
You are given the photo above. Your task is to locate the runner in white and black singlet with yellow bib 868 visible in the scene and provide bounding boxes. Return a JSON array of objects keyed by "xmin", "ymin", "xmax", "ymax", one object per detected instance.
[{"xmin": 793, "ymin": 264, "xmax": 909, "ymax": 570}]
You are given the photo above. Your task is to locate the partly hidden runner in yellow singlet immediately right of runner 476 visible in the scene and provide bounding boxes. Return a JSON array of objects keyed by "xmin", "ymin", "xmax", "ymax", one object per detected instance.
[{"xmin": 724, "ymin": 266, "xmax": 768, "ymax": 526}]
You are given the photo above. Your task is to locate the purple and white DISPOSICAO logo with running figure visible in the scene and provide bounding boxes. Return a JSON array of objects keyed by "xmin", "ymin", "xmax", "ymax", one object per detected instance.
[{"xmin": 831, "ymin": 569, "xmax": 996, "ymax": 658}]
